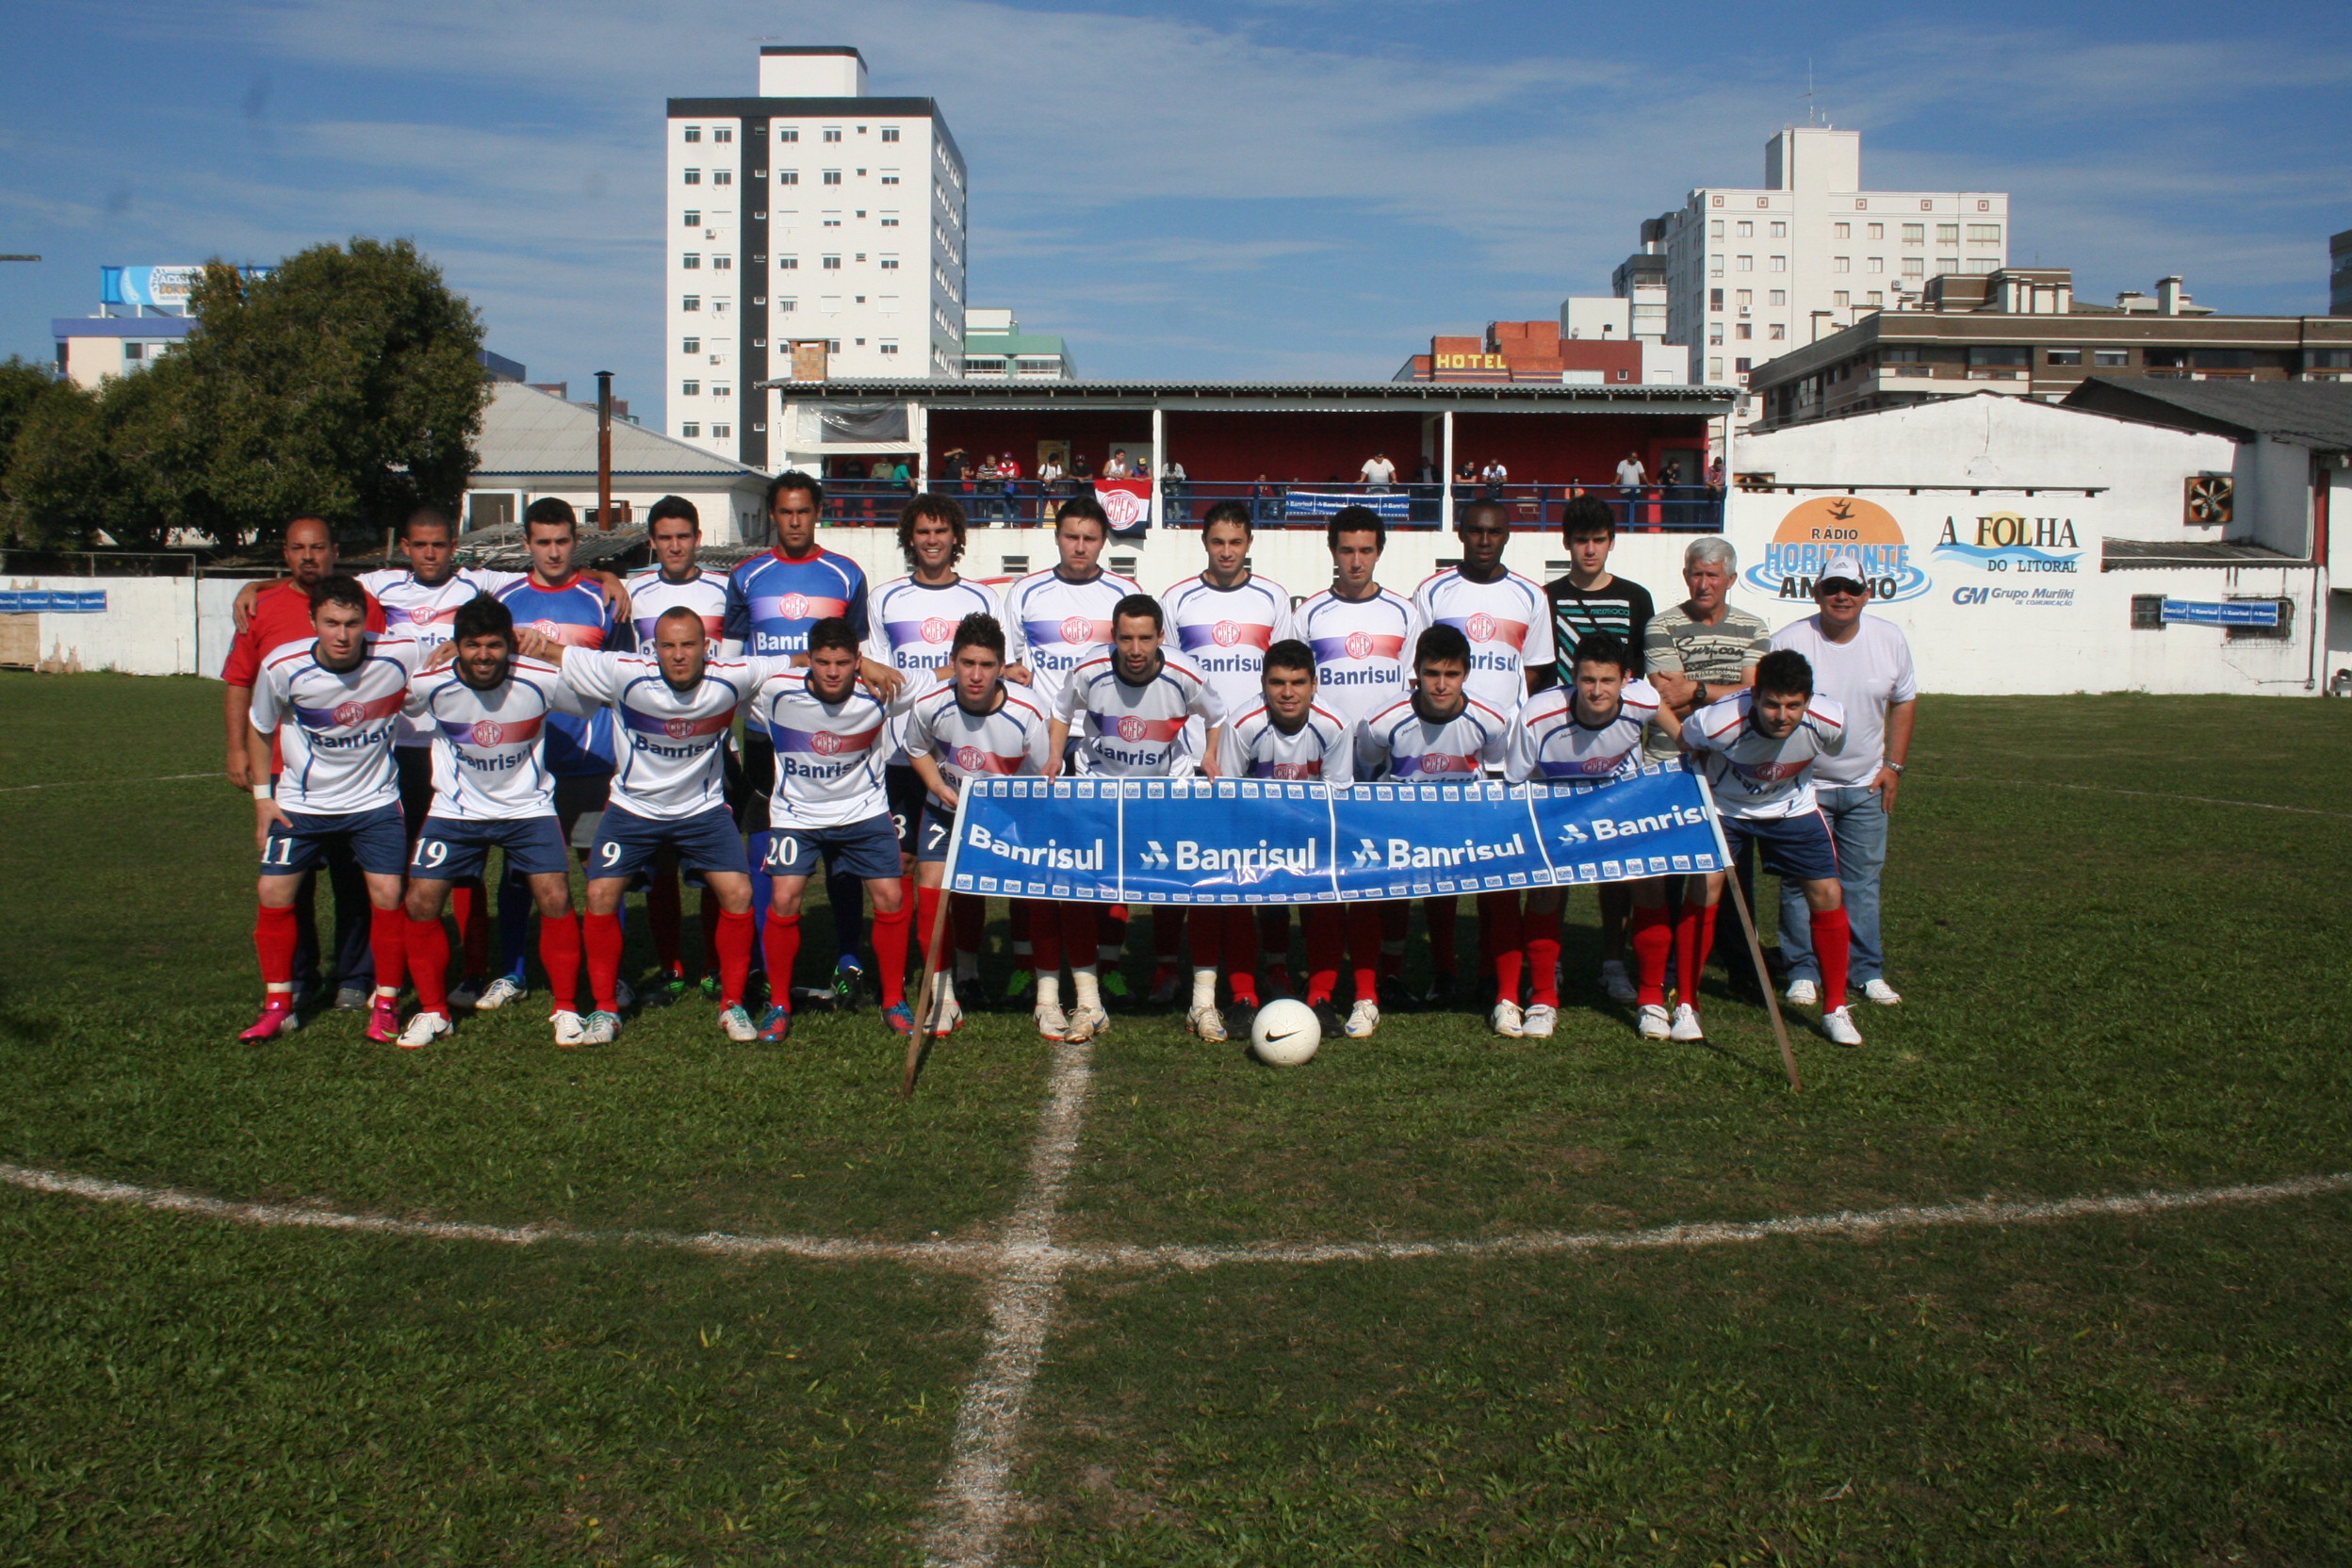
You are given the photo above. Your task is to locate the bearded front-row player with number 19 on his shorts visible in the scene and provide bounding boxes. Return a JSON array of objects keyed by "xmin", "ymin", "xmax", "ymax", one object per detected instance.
[{"xmin": 400, "ymin": 597, "xmax": 588, "ymax": 1051}]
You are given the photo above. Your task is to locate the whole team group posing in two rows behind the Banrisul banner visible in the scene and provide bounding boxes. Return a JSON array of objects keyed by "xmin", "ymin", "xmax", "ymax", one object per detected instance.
[{"xmin": 223, "ymin": 472, "xmax": 1917, "ymax": 1062}]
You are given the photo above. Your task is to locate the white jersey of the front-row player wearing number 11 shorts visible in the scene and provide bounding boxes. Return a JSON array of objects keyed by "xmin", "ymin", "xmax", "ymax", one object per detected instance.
[{"xmin": 254, "ymin": 635, "xmax": 423, "ymax": 816}]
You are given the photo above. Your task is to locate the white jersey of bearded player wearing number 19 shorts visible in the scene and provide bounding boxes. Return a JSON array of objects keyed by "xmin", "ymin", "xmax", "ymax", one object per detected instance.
[{"xmin": 407, "ymin": 659, "xmax": 590, "ymax": 823}]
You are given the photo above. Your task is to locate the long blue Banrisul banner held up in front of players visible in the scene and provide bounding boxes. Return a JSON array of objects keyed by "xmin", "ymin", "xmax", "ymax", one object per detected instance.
[{"xmin": 948, "ymin": 766, "xmax": 1724, "ymax": 903}]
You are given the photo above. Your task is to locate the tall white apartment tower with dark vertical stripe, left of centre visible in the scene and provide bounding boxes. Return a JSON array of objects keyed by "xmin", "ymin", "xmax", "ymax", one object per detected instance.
[{"xmin": 663, "ymin": 47, "xmax": 964, "ymax": 470}]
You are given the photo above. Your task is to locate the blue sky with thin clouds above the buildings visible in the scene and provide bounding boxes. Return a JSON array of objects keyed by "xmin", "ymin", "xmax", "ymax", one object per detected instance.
[{"xmin": 0, "ymin": 0, "xmax": 2352, "ymax": 418}]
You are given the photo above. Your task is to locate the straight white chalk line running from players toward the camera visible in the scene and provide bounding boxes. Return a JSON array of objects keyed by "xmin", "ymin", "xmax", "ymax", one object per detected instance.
[{"xmin": 924, "ymin": 1041, "xmax": 1094, "ymax": 1568}]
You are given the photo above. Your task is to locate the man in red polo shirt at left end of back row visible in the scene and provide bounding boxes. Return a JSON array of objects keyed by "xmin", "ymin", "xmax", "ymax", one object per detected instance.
[{"xmin": 221, "ymin": 514, "xmax": 384, "ymax": 1011}]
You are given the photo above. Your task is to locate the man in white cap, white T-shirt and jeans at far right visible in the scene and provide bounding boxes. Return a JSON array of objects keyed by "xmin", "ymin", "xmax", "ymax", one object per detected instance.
[{"xmin": 1771, "ymin": 550, "xmax": 1919, "ymax": 1006}]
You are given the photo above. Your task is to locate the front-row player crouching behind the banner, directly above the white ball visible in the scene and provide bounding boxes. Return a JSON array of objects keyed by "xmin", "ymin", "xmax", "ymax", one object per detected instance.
[{"xmin": 1192, "ymin": 629, "xmax": 1380, "ymax": 1041}]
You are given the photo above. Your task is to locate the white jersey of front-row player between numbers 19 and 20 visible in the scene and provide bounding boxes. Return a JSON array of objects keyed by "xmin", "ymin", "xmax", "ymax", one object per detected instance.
[{"xmin": 564, "ymin": 649, "xmax": 788, "ymax": 823}]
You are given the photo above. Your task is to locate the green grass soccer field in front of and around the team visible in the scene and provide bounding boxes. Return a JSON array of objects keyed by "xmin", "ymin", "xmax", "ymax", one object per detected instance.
[{"xmin": 0, "ymin": 675, "xmax": 2352, "ymax": 1566}]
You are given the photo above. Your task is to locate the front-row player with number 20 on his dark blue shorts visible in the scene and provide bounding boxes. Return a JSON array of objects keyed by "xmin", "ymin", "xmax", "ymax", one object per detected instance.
[{"xmin": 753, "ymin": 616, "xmax": 915, "ymax": 1044}]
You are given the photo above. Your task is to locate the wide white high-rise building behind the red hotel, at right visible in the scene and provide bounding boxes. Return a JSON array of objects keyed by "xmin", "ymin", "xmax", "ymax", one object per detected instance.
[{"xmin": 1642, "ymin": 124, "xmax": 2009, "ymax": 385}]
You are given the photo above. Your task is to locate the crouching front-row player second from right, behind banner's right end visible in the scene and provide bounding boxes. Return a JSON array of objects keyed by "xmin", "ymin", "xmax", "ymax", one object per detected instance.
[{"xmin": 1495, "ymin": 632, "xmax": 1696, "ymax": 1039}]
